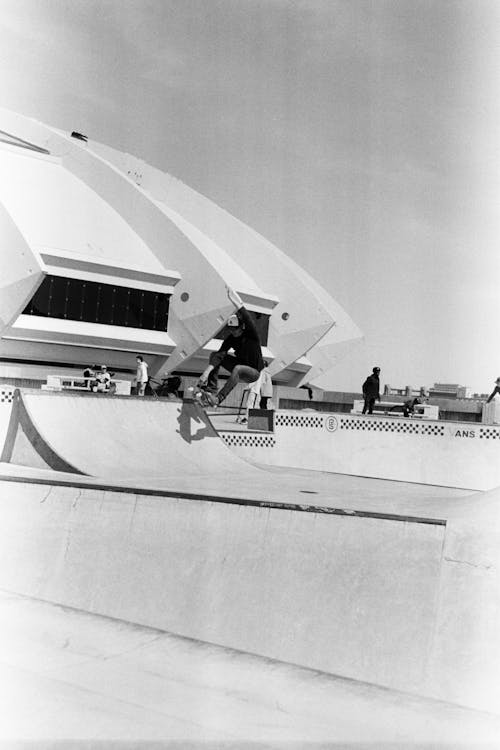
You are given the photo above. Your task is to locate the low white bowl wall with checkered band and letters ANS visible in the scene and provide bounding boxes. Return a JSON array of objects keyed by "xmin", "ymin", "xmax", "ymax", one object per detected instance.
[{"xmin": 221, "ymin": 411, "xmax": 500, "ymax": 490}]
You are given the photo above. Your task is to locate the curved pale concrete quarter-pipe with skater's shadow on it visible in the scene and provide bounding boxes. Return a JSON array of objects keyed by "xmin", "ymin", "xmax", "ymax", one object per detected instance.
[{"xmin": 1, "ymin": 390, "xmax": 260, "ymax": 481}]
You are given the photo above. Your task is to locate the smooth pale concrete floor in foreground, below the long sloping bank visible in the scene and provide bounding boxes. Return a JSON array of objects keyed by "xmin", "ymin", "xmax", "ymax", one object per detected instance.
[{"xmin": 0, "ymin": 592, "xmax": 500, "ymax": 750}]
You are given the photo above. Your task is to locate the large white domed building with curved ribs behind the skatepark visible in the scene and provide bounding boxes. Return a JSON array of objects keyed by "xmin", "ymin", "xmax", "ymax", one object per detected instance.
[{"xmin": 0, "ymin": 110, "xmax": 361, "ymax": 386}]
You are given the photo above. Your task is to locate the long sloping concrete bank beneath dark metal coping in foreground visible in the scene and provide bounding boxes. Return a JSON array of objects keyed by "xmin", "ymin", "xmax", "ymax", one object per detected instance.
[{"xmin": 0, "ymin": 482, "xmax": 500, "ymax": 711}]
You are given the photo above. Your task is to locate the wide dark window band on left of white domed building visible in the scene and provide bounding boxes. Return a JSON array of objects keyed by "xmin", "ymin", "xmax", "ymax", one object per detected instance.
[{"xmin": 23, "ymin": 276, "xmax": 170, "ymax": 331}]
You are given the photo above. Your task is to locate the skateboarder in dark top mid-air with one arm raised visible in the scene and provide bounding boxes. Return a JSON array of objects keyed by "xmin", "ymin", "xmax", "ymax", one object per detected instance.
[{"xmin": 198, "ymin": 287, "xmax": 264, "ymax": 406}]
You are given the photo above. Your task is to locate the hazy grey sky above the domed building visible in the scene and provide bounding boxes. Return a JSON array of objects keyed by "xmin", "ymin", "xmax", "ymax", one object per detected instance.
[{"xmin": 0, "ymin": 0, "xmax": 500, "ymax": 392}]
